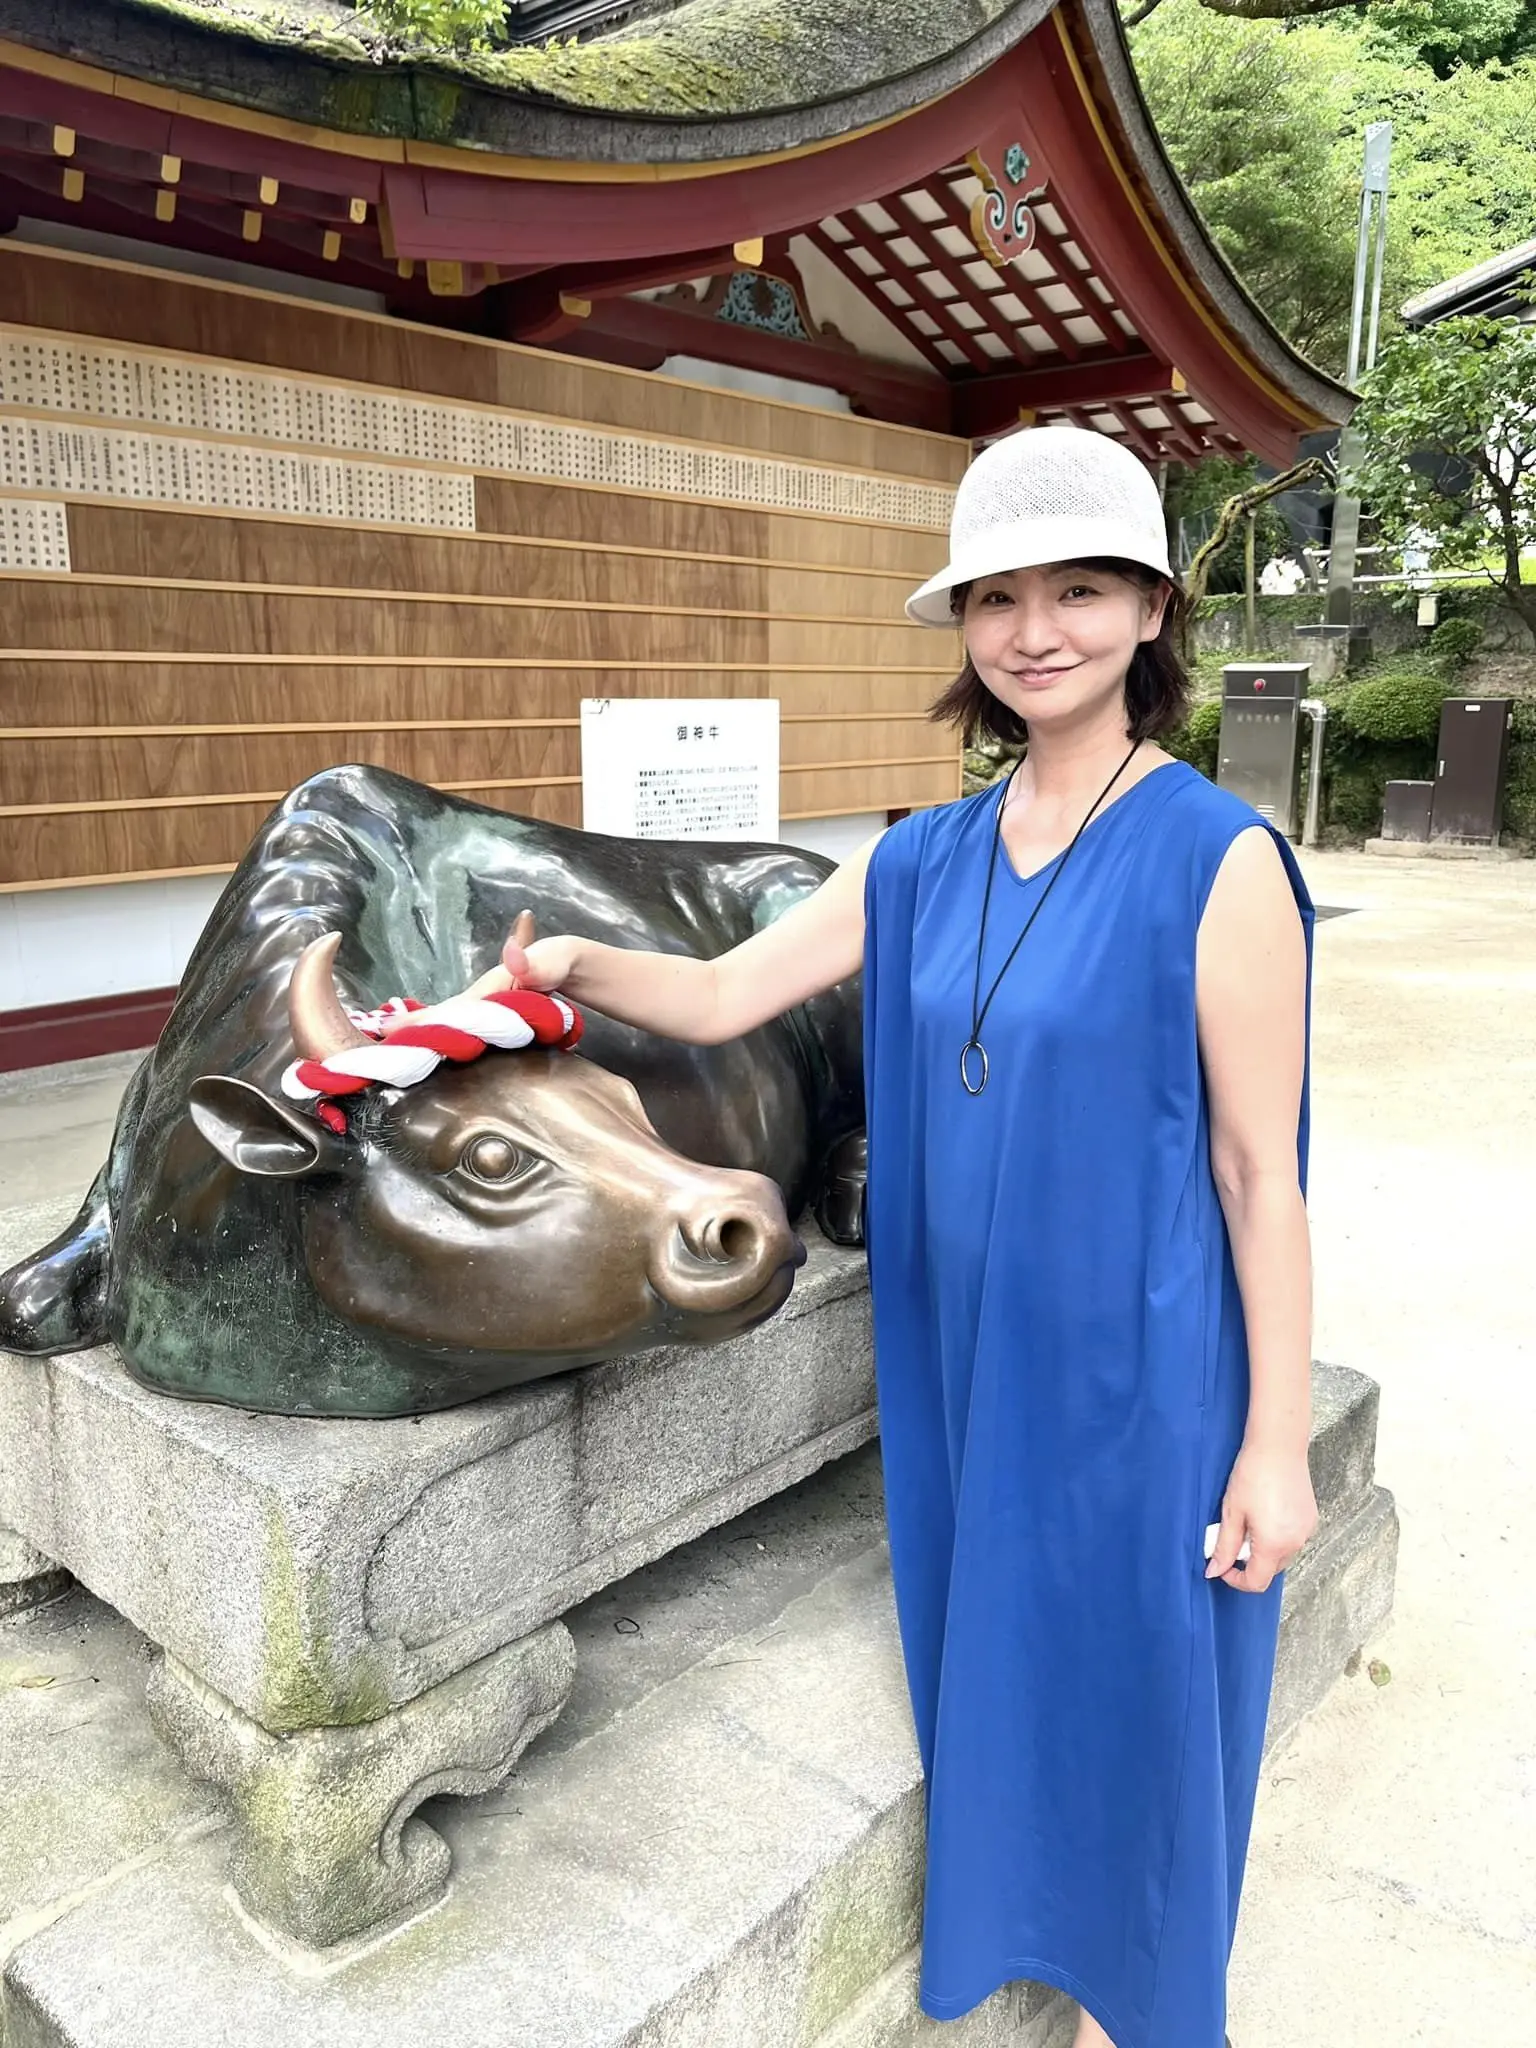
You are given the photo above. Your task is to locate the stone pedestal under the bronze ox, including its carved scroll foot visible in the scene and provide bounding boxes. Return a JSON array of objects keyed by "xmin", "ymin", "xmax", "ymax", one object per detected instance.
[{"xmin": 0, "ymin": 1239, "xmax": 874, "ymax": 1950}]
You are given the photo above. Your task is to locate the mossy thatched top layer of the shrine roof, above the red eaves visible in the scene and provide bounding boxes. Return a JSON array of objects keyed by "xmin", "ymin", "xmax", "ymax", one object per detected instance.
[{"xmin": 0, "ymin": 0, "xmax": 1053, "ymax": 146}]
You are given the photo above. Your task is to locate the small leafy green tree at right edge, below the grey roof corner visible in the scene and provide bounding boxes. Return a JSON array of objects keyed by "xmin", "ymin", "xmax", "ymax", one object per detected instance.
[{"xmin": 1354, "ymin": 319, "xmax": 1536, "ymax": 633}]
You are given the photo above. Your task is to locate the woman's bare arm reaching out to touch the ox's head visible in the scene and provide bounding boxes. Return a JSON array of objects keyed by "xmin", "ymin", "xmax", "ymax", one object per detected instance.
[{"xmin": 450, "ymin": 834, "xmax": 881, "ymax": 1044}]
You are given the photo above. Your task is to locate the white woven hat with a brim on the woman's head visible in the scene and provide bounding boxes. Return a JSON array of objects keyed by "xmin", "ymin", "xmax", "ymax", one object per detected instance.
[{"xmin": 907, "ymin": 426, "xmax": 1174, "ymax": 627}]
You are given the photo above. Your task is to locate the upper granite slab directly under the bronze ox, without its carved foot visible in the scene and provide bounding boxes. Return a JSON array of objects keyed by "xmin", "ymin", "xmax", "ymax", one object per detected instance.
[{"xmin": 0, "ymin": 1233, "xmax": 874, "ymax": 1735}]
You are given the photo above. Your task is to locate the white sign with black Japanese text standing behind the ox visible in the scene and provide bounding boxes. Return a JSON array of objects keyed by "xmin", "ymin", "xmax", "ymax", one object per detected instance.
[{"xmin": 582, "ymin": 696, "xmax": 778, "ymax": 842}]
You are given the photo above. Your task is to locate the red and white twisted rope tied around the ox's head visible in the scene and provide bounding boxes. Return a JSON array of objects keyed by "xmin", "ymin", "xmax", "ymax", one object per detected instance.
[{"xmin": 281, "ymin": 989, "xmax": 582, "ymax": 1130}]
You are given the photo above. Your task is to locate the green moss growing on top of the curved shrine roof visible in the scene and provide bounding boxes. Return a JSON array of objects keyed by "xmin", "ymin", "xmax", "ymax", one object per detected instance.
[{"xmin": 121, "ymin": 0, "xmax": 1028, "ymax": 119}]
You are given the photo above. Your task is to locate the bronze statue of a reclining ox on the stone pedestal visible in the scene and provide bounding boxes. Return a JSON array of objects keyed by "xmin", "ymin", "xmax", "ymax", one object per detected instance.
[{"xmin": 0, "ymin": 768, "xmax": 864, "ymax": 1415}]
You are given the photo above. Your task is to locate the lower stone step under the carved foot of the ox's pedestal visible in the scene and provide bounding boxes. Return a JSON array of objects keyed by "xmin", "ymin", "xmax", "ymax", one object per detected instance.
[{"xmin": 0, "ymin": 1368, "xmax": 1395, "ymax": 2048}]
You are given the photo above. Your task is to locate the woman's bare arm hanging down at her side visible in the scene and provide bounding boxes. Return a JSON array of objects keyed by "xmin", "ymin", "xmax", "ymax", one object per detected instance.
[{"xmin": 1196, "ymin": 829, "xmax": 1317, "ymax": 1593}]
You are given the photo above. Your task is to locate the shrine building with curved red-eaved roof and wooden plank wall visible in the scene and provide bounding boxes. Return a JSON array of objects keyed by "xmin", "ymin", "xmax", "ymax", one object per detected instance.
[{"xmin": 0, "ymin": 0, "xmax": 1350, "ymax": 1067}]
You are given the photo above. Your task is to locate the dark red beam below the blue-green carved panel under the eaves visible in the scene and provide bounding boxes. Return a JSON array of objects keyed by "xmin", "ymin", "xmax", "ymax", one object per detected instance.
[{"xmin": 557, "ymin": 299, "xmax": 950, "ymax": 434}]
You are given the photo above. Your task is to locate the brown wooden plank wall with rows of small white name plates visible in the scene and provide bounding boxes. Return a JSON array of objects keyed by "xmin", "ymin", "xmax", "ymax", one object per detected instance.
[{"xmin": 0, "ymin": 244, "xmax": 965, "ymax": 889}]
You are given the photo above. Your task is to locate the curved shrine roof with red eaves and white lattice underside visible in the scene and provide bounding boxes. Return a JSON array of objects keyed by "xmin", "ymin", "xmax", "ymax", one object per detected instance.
[{"xmin": 0, "ymin": 0, "xmax": 1352, "ymax": 463}]
